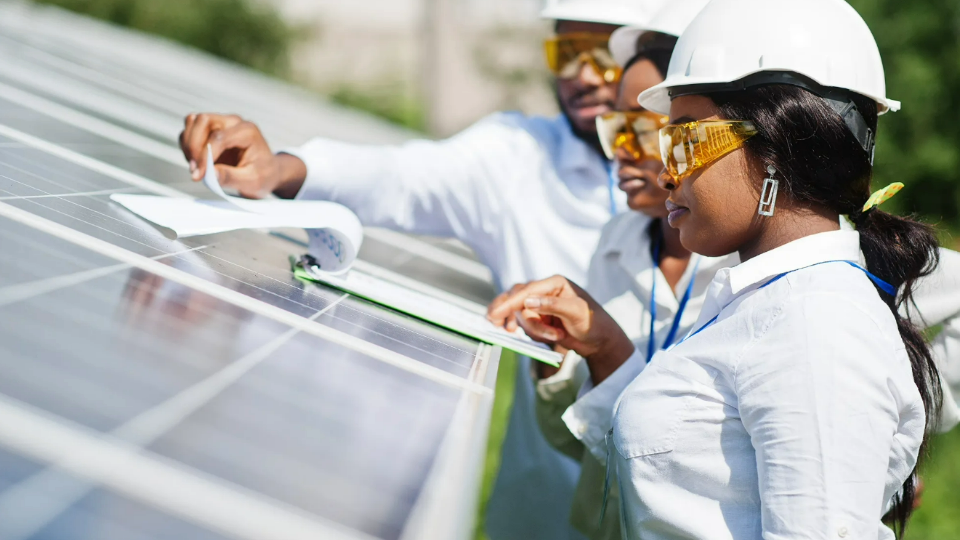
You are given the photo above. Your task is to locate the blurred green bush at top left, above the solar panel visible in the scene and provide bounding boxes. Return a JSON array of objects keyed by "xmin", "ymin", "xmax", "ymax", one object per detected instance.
[{"xmin": 35, "ymin": 0, "xmax": 303, "ymax": 75}]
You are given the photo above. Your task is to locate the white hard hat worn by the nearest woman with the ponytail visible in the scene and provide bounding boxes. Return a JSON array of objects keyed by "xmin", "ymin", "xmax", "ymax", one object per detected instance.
[{"xmin": 640, "ymin": 0, "xmax": 900, "ymax": 116}]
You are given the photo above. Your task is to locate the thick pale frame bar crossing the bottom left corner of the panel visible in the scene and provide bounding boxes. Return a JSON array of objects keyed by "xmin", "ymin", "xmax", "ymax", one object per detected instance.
[{"xmin": 0, "ymin": 395, "xmax": 373, "ymax": 540}]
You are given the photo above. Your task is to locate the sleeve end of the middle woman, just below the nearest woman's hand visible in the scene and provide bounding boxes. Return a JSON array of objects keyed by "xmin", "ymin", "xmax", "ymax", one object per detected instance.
[{"xmin": 536, "ymin": 351, "xmax": 589, "ymax": 461}]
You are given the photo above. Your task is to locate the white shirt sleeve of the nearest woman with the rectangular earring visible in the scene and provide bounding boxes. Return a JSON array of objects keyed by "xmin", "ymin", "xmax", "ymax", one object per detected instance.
[{"xmin": 735, "ymin": 294, "xmax": 924, "ymax": 540}]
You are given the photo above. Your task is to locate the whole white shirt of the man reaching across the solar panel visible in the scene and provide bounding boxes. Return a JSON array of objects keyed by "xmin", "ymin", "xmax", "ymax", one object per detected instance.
[{"xmin": 284, "ymin": 113, "xmax": 626, "ymax": 540}]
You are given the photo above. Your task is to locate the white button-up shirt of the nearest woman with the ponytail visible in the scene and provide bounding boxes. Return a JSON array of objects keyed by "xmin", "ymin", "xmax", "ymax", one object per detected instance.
[{"xmin": 611, "ymin": 231, "xmax": 925, "ymax": 540}]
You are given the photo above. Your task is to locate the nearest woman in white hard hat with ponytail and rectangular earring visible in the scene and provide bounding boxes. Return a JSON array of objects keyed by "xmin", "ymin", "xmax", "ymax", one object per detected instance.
[{"xmin": 492, "ymin": 0, "xmax": 940, "ymax": 539}]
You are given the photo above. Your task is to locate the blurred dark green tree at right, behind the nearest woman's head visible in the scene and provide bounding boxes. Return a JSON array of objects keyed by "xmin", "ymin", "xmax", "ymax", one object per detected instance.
[{"xmin": 849, "ymin": 0, "xmax": 960, "ymax": 232}]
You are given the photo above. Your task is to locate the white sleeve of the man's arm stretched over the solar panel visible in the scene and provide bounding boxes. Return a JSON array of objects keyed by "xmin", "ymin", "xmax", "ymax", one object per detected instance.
[{"xmin": 283, "ymin": 114, "xmax": 542, "ymax": 243}]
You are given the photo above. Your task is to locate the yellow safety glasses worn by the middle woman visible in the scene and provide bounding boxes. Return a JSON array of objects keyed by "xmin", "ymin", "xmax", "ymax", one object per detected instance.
[{"xmin": 597, "ymin": 111, "xmax": 670, "ymax": 161}]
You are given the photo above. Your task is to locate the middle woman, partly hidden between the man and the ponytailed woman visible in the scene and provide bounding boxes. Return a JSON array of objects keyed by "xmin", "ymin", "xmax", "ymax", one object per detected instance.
[{"xmin": 512, "ymin": 4, "xmax": 724, "ymax": 540}]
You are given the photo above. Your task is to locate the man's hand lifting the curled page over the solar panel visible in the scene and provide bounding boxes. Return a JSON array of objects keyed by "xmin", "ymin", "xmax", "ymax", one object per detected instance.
[{"xmin": 180, "ymin": 113, "xmax": 307, "ymax": 199}]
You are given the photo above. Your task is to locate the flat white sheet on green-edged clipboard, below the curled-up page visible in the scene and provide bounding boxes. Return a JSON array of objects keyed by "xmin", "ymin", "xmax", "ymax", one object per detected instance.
[{"xmin": 302, "ymin": 267, "xmax": 563, "ymax": 366}]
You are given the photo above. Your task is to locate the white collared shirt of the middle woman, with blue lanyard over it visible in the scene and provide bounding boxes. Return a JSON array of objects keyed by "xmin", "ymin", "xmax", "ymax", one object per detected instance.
[{"xmin": 537, "ymin": 212, "xmax": 739, "ymax": 540}]
